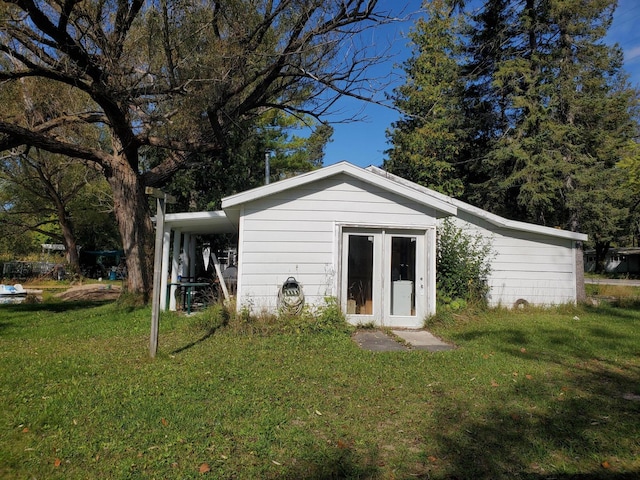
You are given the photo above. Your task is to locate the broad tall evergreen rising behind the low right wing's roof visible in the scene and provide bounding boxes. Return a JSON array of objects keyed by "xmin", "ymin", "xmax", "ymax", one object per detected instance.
[{"xmin": 468, "ymin": 0, "xmax": 635, "ymax": 240}]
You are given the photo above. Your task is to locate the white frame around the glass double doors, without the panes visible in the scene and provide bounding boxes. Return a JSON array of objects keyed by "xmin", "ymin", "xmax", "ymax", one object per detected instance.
[{"xmin": 336, "ymin": 223, "xmax": 436, "ymax": 328}]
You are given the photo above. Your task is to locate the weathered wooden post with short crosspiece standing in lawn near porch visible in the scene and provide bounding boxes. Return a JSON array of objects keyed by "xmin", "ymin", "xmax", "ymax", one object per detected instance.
[{"xmin": 145, "ymin": 187, "xmax": 176, "ymax": 358}]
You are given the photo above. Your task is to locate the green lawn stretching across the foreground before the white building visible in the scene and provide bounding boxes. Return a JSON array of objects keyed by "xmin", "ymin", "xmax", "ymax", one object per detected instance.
[{"xmin": 0, "ymin": 303, "xmax": 640, "ymax": 480}]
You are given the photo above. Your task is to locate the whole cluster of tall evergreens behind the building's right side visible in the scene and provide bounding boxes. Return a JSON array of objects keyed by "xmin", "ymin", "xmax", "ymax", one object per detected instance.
[{"xmin": 386, "ymin": 0, "xmax": 638, "ymax": 266}]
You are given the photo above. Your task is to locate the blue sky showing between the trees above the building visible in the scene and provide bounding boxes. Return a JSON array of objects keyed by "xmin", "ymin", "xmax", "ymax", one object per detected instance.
[{"xmin": 324, "ymin": 0, "xmax": 640, "ymax": 167}]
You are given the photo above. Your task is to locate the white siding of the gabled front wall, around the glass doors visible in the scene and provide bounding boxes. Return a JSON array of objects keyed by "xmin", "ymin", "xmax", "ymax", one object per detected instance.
[{"xmin": 238, "ymin": 174, "xmax": 435, "ymax": 311}]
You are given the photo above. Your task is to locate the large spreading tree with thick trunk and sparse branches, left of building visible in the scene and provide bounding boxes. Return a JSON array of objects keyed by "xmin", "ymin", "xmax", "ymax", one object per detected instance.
[{"xmin": 0, "ymin": 0, "xmax": 381, "ymax": 299}]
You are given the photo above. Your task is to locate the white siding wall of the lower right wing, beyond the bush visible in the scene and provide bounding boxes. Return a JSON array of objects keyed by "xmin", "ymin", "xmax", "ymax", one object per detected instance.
[{"xmin": 448, "ymin": 210, "xmax": 576, "ymax": 307}]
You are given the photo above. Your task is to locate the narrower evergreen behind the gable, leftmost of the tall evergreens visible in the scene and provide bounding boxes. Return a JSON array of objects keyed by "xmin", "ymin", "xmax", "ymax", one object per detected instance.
[{"xmin": 383, "ymin": 0, "xmax": 464, "ymax": 196}]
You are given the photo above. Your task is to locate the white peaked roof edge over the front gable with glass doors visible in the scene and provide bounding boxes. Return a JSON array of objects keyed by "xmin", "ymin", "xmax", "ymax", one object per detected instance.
[{"xmin": 222, "ymin": 162, "xmax": 457, "ymax": 216}]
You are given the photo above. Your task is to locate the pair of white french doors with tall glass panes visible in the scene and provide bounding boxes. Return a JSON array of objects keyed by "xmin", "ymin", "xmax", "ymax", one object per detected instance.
[{"xmin": 341, "ymin": 228, "xmax": 426, "ymax": 328}]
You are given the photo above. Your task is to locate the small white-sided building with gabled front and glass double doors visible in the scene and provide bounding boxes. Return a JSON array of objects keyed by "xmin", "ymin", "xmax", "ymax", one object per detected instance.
[{"xmin": 161, "ymin": 162, "xmax": 587, "ymax": 328}]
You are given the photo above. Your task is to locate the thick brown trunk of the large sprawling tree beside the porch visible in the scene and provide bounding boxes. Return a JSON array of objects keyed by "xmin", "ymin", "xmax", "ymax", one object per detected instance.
[{"xmin": 107, "ymin": 155, "xmax": 153, "ymax": 303}]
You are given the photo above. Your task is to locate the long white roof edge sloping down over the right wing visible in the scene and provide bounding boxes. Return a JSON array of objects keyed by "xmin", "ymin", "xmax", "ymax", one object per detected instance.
[{"xmin": 367, "ymin": 166, "xmax": 588, "ymax": 241}]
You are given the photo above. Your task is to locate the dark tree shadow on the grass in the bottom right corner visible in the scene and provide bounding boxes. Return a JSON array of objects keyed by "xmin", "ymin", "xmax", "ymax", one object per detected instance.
[{"xmin": 431, "ymin": 344, "xmax": 640, "ymax": 480}]
